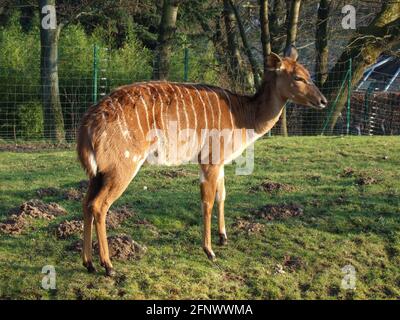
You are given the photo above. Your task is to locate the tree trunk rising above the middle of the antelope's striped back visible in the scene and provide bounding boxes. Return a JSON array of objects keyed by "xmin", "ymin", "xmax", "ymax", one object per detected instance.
[{"xmin": 153, "ymin": 0, "xmax": 179, "ymax": 80}]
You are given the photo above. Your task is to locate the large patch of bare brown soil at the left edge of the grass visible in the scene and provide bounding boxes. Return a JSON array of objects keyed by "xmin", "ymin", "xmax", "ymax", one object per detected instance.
[{"xmin": 0, "ymin": 199, "xmax": 67, "ymax": 234}]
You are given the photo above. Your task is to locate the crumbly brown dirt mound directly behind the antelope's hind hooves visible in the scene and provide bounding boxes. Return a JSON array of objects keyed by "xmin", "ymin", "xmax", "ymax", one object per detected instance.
[{"xmin": 68, "ymin": 235, "xmax": 147, "ymax": 260}]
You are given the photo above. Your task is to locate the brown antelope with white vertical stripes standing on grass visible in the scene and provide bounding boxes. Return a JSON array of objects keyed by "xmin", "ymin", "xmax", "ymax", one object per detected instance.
[{"xmin": 77, "ymin": 47, "xmax": 327, "ymax": 276}]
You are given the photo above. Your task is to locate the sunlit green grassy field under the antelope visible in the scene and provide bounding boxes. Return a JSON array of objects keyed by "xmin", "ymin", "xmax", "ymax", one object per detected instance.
[{"xmin": 0, "ymin": 137, "xmax": 400, "ymax": 299}]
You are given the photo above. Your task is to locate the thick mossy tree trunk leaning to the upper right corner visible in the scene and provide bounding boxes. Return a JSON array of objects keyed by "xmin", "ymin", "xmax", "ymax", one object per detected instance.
[{"xmin": 321, "ymin": 2, "xmax": 400, "ymax": 133}]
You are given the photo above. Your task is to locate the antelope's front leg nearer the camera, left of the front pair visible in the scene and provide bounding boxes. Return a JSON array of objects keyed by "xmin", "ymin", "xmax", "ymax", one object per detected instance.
[{"xmin": 200, "ymin": 165, "xmax": 220, "ymax": 260}]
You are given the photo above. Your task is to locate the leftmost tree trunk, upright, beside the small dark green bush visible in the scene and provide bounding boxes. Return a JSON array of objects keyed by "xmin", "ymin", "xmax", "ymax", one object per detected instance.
[{"xmin": 39, "ymin": 0, "xmax": 65, "ymax": 142}]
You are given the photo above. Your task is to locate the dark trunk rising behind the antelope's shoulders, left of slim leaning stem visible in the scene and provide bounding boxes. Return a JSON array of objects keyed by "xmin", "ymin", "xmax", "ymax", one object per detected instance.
[{"xmin": 223, "ymin": 0, "xmax": 246, "ymax": 89}]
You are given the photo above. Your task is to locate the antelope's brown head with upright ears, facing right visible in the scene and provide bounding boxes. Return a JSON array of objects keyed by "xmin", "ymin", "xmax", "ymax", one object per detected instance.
[{"xmin": 267, "ymin": 46, "xmax": 328, "ymax": 109}]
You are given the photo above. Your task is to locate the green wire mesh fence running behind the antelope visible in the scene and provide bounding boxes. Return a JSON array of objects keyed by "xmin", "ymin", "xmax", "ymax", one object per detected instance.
[{"xmin": 0, "ymin": 44, "xmax": 400, "ymax": 141}]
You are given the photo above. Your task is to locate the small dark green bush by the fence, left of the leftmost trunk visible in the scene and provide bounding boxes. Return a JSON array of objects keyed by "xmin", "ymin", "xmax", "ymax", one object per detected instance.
[{"xmin": 17, "ymin": 102, "xmax": 43, "ymax": 139}]
